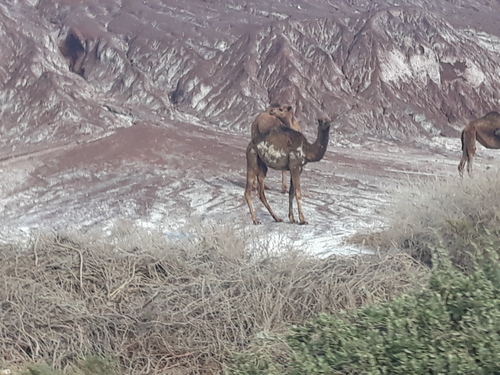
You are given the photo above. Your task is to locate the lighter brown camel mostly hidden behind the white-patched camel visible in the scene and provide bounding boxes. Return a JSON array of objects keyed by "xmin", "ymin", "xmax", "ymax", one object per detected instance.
[{"xmin": 251, "ymin": 104, "xmax": 301, "ymax": 194}]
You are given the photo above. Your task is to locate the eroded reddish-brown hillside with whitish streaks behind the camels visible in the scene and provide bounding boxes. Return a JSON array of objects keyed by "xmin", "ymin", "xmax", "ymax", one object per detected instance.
[{"xmin": 0, "ymin": 0, "xmax": 500, "ymax": 150}]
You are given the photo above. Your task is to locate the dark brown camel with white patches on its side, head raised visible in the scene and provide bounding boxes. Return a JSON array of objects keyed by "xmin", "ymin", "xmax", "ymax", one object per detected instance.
[{"xmin": 245, "ymin": 119, "xmax": 331, "ymax": 224}]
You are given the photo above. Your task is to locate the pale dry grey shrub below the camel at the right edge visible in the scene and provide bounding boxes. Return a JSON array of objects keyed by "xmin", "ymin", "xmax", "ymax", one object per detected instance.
[{"xmin": 351, "ymin": 171, "xmax": 500, "ymax": 267}]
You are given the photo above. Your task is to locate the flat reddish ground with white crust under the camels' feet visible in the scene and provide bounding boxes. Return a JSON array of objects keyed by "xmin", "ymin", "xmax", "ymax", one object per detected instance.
[{"xmin": 0, "ymin": 122, "xmax": 500, "ymax": 254}]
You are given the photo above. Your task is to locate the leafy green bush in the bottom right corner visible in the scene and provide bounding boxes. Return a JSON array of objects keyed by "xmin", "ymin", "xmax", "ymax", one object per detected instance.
[{"xmin": 228, "ymin": 249, "xmax": 500, "ymax": 375}]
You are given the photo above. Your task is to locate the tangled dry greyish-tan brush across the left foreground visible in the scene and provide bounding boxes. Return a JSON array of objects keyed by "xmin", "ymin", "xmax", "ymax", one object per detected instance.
[{"xmin": 0, "ymin": 222, "xmax": 427, "ymax": 375}]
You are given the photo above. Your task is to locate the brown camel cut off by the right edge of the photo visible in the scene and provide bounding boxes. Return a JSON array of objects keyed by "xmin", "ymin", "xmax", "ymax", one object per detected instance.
[{"xmin": 458, "ymin": 112, "xmax": 500, "ymax": 178}]
